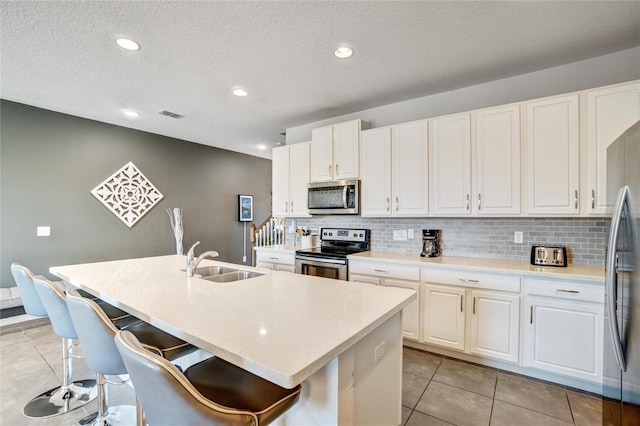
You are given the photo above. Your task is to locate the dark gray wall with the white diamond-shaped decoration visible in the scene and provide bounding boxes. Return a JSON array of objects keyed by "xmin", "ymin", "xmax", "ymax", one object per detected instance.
[{"xmin": 0, "ymin": 100, "xmax": 271, "ymax": 287}]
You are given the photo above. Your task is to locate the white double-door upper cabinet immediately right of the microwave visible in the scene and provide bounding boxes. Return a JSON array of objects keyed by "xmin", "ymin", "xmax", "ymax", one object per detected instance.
[{"xmin": 360, "ymin": 120, "xmax": 428, "ymax": 216}]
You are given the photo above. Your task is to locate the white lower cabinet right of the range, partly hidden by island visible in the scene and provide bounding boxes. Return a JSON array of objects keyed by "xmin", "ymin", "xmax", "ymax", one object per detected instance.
[{"xmin": 349, "ymin": 260, "xmax": 420, "ymax": 340}]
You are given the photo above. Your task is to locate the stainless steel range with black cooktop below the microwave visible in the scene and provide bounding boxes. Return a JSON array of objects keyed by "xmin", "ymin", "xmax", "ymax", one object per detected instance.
[{"xmin": 296, "ymin": 228, "xmax": 371, "ymax": 281}]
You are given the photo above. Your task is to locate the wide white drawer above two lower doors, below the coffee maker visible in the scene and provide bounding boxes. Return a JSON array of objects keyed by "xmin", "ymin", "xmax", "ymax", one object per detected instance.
[{"xmin": 422, "ymin": 268, "xmax": 520, "ymax": 293}]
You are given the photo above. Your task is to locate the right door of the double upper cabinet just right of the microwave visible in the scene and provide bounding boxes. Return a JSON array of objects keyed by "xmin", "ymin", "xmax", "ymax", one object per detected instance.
[{"xmin": 391, "ymin": 120, "xmax": 429, "ymax": 216}]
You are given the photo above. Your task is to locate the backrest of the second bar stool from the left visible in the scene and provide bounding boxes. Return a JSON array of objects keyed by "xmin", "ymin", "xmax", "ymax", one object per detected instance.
[{"xmin": 33, "ymin": 275, "xmax": 78, "ymax": 339}]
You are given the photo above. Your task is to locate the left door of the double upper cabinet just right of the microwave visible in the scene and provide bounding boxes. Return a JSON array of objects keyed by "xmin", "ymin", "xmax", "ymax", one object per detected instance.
[{"xmin": 360, "ymin": 127, "xmax": 391, "ymax": 216}]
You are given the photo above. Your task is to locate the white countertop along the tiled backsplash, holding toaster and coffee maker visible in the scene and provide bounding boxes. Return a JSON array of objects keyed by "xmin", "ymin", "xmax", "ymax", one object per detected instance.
[{"xmin": 349, "ymin": 251, "xmax": 604, "ymax": 284}]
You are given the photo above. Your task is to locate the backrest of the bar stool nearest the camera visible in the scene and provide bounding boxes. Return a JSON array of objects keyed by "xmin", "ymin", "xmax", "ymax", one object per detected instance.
[{"xmin": 115, "ymin": 330, "xmax": 258, "ymax": 426}]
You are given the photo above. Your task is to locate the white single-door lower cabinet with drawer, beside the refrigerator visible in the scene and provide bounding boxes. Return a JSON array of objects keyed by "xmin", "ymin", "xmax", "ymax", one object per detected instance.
[{"xmin": 524, "ymin": 280, "xmax": 604, "ymax": 382}]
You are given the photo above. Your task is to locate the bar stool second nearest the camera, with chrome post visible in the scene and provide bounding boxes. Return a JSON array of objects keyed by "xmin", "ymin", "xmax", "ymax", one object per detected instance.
[{"xmin": 67, "ymin": 289, "xmax": 197, "ymax": 425}]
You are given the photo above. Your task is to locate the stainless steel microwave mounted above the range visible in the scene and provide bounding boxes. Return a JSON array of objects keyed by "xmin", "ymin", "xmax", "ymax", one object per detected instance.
[{"xmin": 308, "ymin": 179, "xmax": 360, "ymax": 214}]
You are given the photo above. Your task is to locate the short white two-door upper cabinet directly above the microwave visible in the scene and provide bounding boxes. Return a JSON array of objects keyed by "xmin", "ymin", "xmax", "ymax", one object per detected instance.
[{"xmin": 310, "ymin": 120, "xmax": 362, "ymax": 182}]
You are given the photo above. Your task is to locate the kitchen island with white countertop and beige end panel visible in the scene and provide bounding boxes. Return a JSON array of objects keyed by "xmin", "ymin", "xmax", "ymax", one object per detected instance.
[{"xmin": 50, "ymin": 255, "xmax": 416, "ymax": 425}]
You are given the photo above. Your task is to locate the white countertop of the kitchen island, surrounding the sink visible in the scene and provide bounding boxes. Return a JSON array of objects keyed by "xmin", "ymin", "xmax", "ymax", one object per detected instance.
[{"xmin": 50, "ymin": 255, "xmax": 416, "ymax": 388}]
